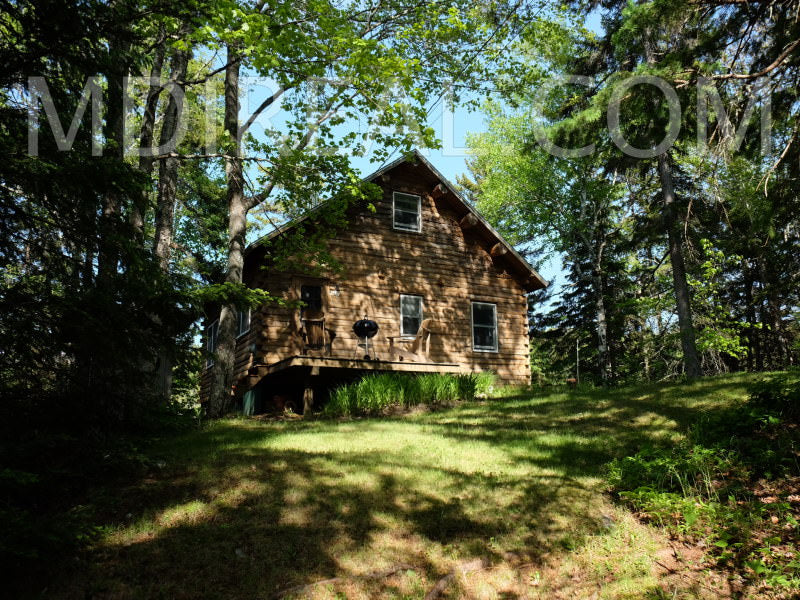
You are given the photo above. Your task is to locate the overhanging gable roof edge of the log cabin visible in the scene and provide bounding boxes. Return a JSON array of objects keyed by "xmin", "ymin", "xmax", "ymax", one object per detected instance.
[{"xmin": 245, "ymin": 150, "xmax": 549, "ymax": 291}]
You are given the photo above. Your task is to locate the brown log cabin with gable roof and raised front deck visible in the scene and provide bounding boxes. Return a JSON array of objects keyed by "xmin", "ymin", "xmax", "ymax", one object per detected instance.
[{"xmin": 201, "ymin": 152, "xmax": 547, "ymax": 414}]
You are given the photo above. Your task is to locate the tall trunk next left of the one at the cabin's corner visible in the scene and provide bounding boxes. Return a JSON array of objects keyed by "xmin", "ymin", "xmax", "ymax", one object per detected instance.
[{"xmin": 149, "ymin": 49, "xmax": 191, "ymax": 402}]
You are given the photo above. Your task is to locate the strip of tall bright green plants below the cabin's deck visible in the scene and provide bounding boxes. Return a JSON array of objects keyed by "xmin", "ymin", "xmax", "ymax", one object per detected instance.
[{"xmin": 323, "ymin": 373, "xmax": 495, "ymax": 416}]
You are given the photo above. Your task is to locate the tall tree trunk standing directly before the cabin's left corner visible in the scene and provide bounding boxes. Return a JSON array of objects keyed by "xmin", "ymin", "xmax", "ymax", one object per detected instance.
[{"xmin": 209, "ymin": 45, "xmax": 242, "ymax": 417}]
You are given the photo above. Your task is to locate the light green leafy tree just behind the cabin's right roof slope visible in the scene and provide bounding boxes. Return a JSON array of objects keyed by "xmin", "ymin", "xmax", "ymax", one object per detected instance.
[{"xmin": 461, "ymin": 106, "xmax": 626, "ymax": 383}]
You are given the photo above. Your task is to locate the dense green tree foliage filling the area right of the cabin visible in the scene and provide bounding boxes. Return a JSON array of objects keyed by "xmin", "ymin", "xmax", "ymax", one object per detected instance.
[{"xmin": 461, "ymin": 0, "xmax": 800, "ymax": 383}]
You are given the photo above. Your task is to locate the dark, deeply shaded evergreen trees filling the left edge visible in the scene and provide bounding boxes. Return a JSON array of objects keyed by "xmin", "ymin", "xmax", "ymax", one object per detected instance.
[{"xmin": 0, "ymin": 0, "xmax": 219, "ymax": 431}]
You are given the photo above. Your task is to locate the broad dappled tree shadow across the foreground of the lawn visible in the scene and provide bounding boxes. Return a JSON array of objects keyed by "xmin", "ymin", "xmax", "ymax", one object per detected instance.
[{"xmin": 39, "ymin": 431, "xmax": 586, "ymax": 598}]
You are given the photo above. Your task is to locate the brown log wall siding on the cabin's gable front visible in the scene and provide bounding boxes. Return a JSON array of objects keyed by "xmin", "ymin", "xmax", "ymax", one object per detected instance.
[{"xmin": 203, "ymin": 163, "xmax": 530, "ymax": 398}]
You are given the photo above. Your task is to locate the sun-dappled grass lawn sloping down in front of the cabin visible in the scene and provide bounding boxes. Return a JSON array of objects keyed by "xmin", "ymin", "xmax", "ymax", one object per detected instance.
[{"xmin": 42, "ymin": 375, "xmax": 768, "ymax": 599}]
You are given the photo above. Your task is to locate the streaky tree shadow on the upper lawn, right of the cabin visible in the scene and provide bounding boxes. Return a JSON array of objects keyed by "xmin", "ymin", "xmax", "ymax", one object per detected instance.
[{"xmin": 424, "ymin": 376, "xmax": 744, "ymax": 468}]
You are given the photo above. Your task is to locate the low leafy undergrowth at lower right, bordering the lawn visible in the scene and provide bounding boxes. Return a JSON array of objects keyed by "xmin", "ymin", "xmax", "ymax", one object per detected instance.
[{"xmin": 608, "ymin": 373, "xmax": 800, "ymax": 589}]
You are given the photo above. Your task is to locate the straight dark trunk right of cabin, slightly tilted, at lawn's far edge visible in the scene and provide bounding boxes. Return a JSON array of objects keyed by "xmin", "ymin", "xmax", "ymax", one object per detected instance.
[{"xmin": 658, "ymin": 153, "xmax": 702, "ymax": 377}]
